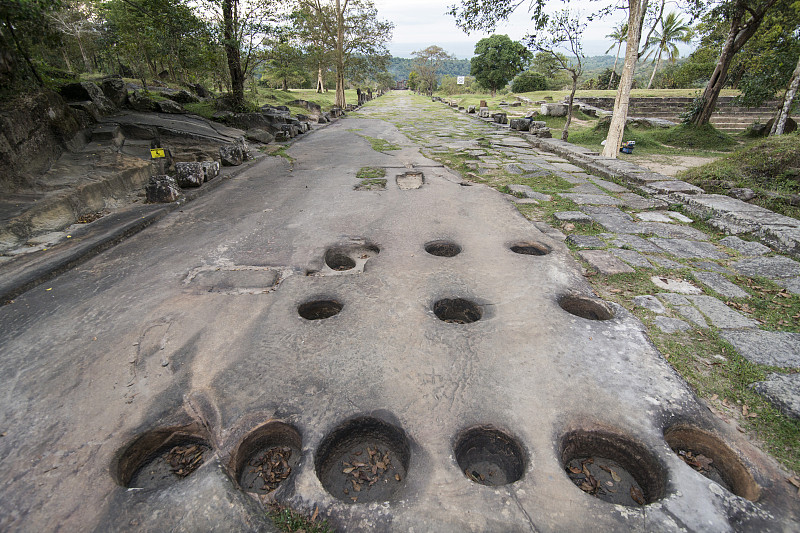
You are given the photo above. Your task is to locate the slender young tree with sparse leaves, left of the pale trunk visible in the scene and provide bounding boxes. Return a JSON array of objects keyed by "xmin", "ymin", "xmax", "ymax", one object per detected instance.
[{"xmin": 529, "ymin": 9, "xmax": 586, "ymax": 141}]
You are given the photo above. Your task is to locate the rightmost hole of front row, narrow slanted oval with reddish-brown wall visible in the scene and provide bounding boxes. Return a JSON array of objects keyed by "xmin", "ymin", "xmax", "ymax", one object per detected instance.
[{"xmin": 664, "ymin": 425, "xmax": 761, "ymax": 501}]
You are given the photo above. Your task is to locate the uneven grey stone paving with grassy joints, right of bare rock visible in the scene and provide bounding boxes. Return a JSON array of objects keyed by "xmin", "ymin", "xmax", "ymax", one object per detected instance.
[{"xmin": 358, "ymin": 93, "xmax": 800, "ymax": 462}]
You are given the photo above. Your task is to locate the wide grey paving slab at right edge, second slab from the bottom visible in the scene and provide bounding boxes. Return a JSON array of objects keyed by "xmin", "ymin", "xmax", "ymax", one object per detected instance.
[{"xmin": 720, "ymin": 330, "xmax": 800, "ymax": 368}]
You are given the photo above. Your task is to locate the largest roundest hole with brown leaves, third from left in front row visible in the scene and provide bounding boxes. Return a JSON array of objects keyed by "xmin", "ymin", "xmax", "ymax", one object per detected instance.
[{"xmin": 315, "ymin": 417, "xmax": 411, "ymax": 503}]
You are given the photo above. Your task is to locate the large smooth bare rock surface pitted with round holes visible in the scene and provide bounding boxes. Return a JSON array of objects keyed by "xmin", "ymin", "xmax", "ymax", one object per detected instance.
[{"xmin": 0, "ymin": 92, "xmax": 798, "ymax": 533}]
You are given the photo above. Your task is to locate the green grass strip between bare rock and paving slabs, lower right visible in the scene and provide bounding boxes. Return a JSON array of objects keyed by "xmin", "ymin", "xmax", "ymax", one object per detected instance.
[{"xmin": 589, "ymin": 269, "xmax": 800, "ymax": 473}]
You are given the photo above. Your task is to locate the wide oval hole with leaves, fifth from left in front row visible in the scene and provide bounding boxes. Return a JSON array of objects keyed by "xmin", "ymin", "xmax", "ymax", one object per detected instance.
[{"xmin": 561, "ymin": 430, "xmax": 666, "ymax": 507}]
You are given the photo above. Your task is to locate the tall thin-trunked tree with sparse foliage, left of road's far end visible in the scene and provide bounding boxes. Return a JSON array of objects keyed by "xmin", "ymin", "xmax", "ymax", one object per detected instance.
[{"xmin": 298, "ymin": 0, "xmax": 394, "ymax": 107}]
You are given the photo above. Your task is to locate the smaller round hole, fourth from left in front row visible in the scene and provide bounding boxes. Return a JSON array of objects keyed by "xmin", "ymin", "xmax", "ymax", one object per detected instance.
[{"xmin": 454, "ymin": 426, "xmax": 526, "ymax": 487}]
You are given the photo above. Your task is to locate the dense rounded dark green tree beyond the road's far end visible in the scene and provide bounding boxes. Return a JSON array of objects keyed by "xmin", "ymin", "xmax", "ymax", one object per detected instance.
[{"xmin": 470, "ymin": 35, "xmax": 532, "ymax": 96}]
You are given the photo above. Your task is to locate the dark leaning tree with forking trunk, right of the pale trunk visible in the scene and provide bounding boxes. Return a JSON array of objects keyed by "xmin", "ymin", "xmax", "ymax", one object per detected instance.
[{"xmin": 688, "ymin": 0, "xmax": 778, "ymax": 126}]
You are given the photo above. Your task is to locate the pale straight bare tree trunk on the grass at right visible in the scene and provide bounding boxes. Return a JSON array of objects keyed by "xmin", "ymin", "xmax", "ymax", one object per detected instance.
[{"xmin": 603, "ymin": 0, "xmax": 647, "ymax": 159}]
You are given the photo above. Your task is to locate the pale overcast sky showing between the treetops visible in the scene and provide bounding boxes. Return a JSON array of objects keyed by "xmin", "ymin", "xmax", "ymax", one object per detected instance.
[{"xmin": 374, "ymin": 0, "xmax": 690, "ymax": 59}]
